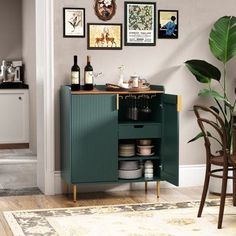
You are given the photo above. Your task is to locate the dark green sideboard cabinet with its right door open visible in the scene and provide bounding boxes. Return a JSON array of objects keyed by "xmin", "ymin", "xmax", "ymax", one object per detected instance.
[{"xmin": 60, "ymin": 86, "xmax": 179, "ymax": 199}]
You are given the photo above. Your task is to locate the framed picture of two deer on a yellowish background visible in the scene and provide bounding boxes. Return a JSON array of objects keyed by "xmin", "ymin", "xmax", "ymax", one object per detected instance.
[{"xmin": 88, "ymin": 23, "xmax": 122, "ymax": 50}]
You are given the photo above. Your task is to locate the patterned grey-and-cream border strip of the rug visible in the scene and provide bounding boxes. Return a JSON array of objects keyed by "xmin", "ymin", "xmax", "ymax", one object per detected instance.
[{"xmin": 3, "ymin": 198, "xmax": 232, "ymax": 236}]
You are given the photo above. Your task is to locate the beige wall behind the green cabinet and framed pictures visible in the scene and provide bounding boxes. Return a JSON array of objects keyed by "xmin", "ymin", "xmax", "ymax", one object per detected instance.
[{"xmin": 54, "ymin": 0, "xmax": 236, "ymax": 170}]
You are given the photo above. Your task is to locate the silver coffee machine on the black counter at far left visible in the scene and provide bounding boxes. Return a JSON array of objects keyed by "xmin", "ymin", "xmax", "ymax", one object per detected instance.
[{"xmin": 0, "ymin": 60, "xmax": 24, "ymax": 83}]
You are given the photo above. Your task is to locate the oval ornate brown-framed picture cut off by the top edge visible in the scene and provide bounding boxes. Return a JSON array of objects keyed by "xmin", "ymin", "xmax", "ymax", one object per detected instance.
[{"xmin": 94, "ymin": 0, "xmax": 116, "ymax": 21}]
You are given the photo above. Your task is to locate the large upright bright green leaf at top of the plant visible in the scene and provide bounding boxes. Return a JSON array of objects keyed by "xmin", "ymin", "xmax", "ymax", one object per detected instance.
[{"xmin": 209, "ymin": 16, "xmax": 236, "ymax": 64}]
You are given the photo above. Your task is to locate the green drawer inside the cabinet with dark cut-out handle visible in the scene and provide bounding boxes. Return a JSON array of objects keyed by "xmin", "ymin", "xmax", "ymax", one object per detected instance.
[{"xmin": 119, "ymin": 123, "xmax": 161, "ymax": 139}]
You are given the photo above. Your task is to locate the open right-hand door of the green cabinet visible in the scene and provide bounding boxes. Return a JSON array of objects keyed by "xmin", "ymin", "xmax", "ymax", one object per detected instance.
[{"xmin": 161, "ymin": 94, "xmax": 179, "ymax": 186}]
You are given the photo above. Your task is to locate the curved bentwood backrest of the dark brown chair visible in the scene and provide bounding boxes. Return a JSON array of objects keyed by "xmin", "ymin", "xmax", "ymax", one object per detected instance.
[{"xmin": 193, "ymin": 105, "xmax": 230, "ymax": 163}]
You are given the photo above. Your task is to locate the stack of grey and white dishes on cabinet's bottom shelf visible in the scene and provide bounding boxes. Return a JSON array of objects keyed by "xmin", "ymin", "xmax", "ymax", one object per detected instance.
[{"xmin": 119, "ymin": 161, "xmax": 142, "ymax": 179}]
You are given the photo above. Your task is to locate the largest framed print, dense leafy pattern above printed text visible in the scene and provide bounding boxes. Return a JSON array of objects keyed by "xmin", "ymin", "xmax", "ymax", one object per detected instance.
[{"xmin": 124, "ymin": 2, "xmax": 156, "ymax": 46}]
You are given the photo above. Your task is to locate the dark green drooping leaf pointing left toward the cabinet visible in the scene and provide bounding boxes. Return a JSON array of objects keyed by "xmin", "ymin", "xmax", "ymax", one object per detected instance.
[{"xmin": 185, "ymin": 60, "xmax": 221, "ymax": 83}]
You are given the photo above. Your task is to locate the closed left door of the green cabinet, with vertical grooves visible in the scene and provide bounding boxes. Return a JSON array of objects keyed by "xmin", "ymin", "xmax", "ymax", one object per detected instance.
[{"xmin": 71, "ymin": 94, "xmax": 118, "ymax": 183}]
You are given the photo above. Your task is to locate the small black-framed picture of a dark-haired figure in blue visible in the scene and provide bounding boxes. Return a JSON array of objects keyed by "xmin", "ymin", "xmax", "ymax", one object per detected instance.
[{"xmin": 158, "ymin": 10, "xmax": 179, "ymax": 39}]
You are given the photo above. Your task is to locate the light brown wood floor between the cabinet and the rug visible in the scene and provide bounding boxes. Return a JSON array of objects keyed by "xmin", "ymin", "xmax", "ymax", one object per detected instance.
[{"xmin": 0, "ymin": 187, "xmax": 218, "ymax": 236}]
